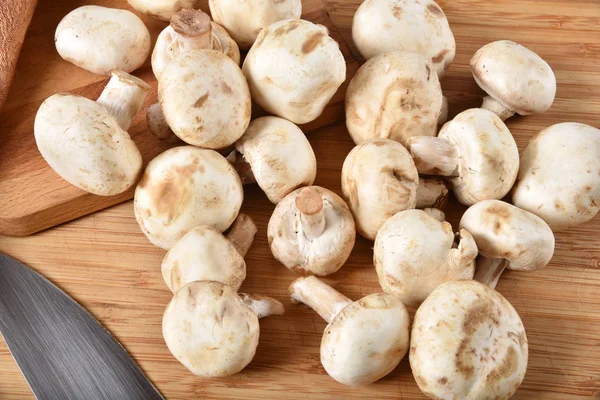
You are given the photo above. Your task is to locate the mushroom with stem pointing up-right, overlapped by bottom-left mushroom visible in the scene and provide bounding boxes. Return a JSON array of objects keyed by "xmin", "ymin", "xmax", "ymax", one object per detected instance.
[{"xmin": 161, "ymin": 214, "xmax": 256, "ymax": 293}]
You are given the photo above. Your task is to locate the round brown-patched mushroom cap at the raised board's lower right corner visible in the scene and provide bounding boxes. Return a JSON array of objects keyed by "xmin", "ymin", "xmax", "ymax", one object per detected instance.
[{"xmin": 134, "ymin": 146, "xmax": 244, "ymax": 250}]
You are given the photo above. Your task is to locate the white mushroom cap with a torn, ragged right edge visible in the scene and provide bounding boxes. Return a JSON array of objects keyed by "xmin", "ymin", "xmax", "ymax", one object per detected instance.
[{"xmin": 373, "ymin": 210, "xmax": 477, "ymax": 307}]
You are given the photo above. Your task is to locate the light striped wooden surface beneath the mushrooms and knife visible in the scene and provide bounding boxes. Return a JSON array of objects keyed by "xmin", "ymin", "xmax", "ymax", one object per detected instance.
[{"xmin": 0, "ymin": 0, "xmax": 600, "ymax": 400}]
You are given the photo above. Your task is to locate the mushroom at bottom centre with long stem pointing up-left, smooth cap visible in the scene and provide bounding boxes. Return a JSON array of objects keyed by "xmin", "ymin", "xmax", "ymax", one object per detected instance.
[{"xmin": 290, "ymin": 276, "xmax": 410, "ymax": 386}]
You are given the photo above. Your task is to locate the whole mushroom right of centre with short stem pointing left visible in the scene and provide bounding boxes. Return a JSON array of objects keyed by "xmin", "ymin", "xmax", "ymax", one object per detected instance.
[{"xmin": 408, "ymin": 108, "xmax": 519, "ymax": 206}]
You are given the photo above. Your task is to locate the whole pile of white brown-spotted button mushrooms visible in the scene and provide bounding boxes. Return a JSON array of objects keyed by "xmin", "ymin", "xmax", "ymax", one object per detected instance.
[{"xmin": 35, "ymin": 0, "xmax": 600, "ymax": 399}]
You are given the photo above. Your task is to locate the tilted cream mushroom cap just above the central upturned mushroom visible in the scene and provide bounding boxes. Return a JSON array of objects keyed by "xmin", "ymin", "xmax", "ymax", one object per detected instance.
[{"xmin": 235, "ymin": 117, "xmax": 317, "ymax": 204}]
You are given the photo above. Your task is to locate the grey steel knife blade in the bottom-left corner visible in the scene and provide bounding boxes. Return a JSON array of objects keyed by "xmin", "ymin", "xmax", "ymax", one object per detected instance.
[{"xmin": 0, "ymin": 253, "xmax": 163, "ymax": 400}]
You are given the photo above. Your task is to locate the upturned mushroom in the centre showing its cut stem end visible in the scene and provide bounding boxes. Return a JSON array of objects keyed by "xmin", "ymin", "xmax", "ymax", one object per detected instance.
[{"xmin": 267, "ymin": 186, "xmax": 356, "ymax": 276}]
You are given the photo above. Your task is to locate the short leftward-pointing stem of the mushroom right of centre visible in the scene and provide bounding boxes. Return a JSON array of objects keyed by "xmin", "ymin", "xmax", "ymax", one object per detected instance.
[{"xmin": 408, "ymin": 136, "xmax": 458, "ymax": 176}]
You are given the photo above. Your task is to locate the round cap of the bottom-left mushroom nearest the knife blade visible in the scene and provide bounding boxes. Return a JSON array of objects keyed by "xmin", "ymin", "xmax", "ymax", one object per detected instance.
[{"xmin": 162, "ymin": 281, "xmax": 260, "ymax": 378}]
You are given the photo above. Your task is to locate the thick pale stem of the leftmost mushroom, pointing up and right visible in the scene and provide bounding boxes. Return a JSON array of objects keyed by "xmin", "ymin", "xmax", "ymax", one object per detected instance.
[{"xmin": 96, "ymin": 70, "xmax": 150, "ymax": 131}]
